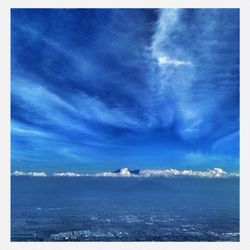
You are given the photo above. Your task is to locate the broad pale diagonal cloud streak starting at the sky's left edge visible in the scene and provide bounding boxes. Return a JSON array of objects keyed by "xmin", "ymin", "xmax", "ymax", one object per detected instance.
[{"xmin": 11, "ymin": 78, "xmax": 96, "ymax": 137}]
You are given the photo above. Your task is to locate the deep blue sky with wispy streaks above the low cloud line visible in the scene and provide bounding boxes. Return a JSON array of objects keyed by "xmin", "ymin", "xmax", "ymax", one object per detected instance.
[{"xmin": 11, "ymin": 9, "xmax": 239, "ymax": 173}]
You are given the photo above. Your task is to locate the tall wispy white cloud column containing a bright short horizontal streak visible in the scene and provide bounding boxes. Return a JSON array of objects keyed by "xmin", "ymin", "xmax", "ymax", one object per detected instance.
[{"xmin": 148, "ymin": 9, "xmax": 218, "ymax": 141}]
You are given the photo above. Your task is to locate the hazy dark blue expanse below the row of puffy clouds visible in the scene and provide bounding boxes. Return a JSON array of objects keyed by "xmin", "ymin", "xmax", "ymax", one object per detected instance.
[{"xmin": 11, "ymin": 176, "xmax": 239, "ymax": 242}]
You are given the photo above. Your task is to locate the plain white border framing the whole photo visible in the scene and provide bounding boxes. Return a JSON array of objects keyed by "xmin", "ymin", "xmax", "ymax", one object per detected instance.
[{"xmin": 0, "ymin": 0, "xmax": 250, "ymax": 250}]
